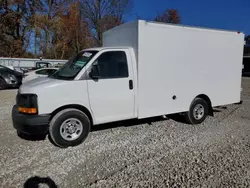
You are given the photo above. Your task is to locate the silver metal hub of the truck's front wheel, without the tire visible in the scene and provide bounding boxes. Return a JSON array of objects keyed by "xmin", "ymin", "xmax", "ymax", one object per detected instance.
[{"xmin": 60, "ymin": 118, "xmax": 83, "ymax": 141}]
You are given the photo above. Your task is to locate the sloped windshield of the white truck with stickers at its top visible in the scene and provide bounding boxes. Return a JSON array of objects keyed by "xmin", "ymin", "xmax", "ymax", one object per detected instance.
[{"xmin": 49, "ymin": 51, "xmax": 98, "ymax": 80}]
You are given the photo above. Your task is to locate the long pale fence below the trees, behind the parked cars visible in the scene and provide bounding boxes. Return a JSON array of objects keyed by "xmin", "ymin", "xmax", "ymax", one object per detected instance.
[{"xmin": 0, "ymin": 57, "xmax": 67, "ymax": 68}]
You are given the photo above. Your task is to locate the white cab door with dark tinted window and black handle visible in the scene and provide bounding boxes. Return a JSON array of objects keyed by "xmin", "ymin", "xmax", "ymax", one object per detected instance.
[{"xmin": 87, "ymin": 50, "xmax": 135, "ymax": 124}]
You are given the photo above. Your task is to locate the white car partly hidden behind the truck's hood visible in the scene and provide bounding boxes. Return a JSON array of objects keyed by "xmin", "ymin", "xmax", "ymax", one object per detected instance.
[{"xmin": 22, "ymin": 67, "xmax": 58, "ymax": 83}]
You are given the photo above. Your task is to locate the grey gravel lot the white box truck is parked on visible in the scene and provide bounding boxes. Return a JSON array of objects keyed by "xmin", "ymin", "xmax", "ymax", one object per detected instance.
[{"xmin": 0, "ymin": 78, "xmax": 250, "ymax": 188}]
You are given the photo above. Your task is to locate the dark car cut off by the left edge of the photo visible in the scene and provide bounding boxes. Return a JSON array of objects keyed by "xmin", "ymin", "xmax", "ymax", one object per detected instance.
[{"xmin": 0, "ymin": 65, "xmax": 23, "ymax": 90}]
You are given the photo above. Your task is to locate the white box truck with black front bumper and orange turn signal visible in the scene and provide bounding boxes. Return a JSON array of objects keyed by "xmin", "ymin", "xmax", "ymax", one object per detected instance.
[{"xmin": 12, "ymin": 20, "xmax": 244, "ymax": 147}]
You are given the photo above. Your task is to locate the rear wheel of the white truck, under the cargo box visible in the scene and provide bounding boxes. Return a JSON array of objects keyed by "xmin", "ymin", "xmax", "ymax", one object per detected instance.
[{"xmin": 185, "ymin": 98, "xmax": 209, "ymax": 125}]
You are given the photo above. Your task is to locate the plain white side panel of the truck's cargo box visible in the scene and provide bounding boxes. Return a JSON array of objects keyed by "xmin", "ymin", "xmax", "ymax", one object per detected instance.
[{"xmin": 139, "ymin": 22, "xmax": 244, "ymax": 118}]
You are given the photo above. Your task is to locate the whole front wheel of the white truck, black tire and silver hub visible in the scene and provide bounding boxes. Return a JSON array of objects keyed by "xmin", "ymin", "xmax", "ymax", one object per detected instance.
[{"xmin": 49, "ymin": 109, "xmax": 90, "ymax": 148}]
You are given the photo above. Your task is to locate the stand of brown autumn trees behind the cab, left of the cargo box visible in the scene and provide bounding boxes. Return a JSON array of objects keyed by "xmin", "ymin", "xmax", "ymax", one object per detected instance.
[{"xmin": 0, "ymin": 0, "xmax": 132, "ymax": 58}]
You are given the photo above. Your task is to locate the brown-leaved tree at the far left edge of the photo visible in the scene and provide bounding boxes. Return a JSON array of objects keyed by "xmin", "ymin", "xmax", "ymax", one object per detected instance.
[{"xmin": 0, "ymin": 0, "xmax": 41, "ymax": 57}]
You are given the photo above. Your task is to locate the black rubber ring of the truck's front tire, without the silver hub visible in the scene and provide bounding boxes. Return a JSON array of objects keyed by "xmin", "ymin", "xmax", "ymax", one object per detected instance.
[{"xmin": 49, "ymin": 108, "xmax": 91, "ymax": 148}]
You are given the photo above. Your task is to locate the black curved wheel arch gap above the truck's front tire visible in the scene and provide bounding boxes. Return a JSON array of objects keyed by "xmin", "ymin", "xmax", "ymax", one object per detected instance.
[{"xmin": 50, "ymin": 104, "xmax": 94, "ymax": 126}]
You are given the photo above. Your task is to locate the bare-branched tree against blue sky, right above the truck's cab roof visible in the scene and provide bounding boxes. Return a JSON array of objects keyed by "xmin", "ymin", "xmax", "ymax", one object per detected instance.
[{"xmin": 80, "ymin": 0, "xmax": 132, "ymax": 45}]
